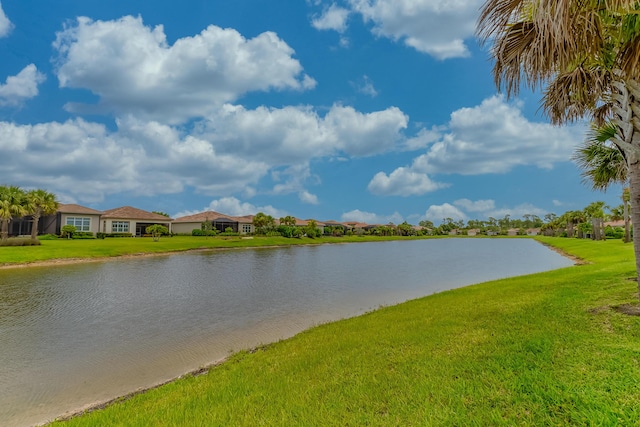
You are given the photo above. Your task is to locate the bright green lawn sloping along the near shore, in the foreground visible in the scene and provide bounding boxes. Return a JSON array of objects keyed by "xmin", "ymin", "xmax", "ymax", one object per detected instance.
[{"xmin": 53, "ymin": 238, "xmax": 640, "ymax": 426}]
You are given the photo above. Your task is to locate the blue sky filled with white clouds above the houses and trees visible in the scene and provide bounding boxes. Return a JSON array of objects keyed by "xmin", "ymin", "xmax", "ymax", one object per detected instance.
[{"xmin": 0, "ymin": 0, "xmax": 621, "ymax": 224}]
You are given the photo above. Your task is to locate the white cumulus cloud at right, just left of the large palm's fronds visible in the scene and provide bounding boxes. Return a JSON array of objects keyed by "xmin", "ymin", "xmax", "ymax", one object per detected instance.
[{"xmin": 412, "ymin": 96, "xmax": 586, "ymax": 175}]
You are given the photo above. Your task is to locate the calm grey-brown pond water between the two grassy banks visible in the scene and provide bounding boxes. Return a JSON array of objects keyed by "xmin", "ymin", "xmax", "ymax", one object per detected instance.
[{"xmin": 0, "ymin": 239, "xmax": 572, "ymax": 426}]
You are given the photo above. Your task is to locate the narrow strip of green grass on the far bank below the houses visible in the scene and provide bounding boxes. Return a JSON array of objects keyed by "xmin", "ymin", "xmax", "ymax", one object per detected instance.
[{"xmin": 0, "ymin": 236, "xmax": 416, "ymax": 266}]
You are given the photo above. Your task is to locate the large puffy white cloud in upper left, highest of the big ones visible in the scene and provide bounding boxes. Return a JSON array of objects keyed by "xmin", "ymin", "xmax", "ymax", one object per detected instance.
[{"xmin": 54, "ymin": 16, "xmax": 316, "ymax": 122}]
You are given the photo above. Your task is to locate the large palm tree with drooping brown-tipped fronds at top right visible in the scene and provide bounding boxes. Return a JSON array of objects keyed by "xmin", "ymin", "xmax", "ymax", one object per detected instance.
[{"xmin": 477, "ymin": 0, "xmax": 640, "ymax": 296}]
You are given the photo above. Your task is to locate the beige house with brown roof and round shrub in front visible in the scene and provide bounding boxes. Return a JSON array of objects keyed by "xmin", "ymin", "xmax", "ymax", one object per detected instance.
[{"xmin": 99, "ymin": 206, "xmax": 172, "ymax": 236}]
